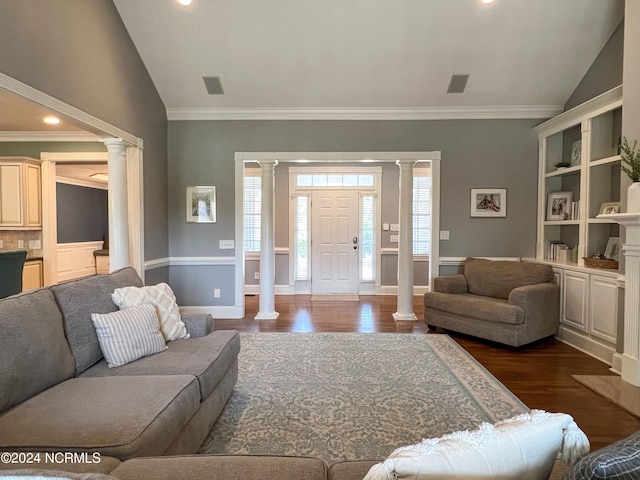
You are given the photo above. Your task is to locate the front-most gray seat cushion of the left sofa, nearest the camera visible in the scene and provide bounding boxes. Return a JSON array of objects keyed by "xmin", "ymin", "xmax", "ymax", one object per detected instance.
[{"xmin": 0, "ymin": 375, "xmax": 200, "ymax": 460}]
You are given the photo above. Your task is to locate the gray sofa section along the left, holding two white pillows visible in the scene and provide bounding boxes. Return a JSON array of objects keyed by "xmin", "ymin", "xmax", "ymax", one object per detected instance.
[{"xmin": 0, "ymin": 268, "xmax": 240, "ymax": 460}]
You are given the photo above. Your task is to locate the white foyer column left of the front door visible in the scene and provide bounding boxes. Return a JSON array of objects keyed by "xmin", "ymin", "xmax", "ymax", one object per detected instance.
[{"xmin": 255, "ymin": 160, "xmax": 279, "ymax": 320}]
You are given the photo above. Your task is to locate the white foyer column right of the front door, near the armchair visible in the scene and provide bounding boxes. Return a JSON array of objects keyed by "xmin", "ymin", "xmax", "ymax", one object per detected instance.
[{"xmin": 393, "ymin": 160, "xmax": 418, "ymax": 320}]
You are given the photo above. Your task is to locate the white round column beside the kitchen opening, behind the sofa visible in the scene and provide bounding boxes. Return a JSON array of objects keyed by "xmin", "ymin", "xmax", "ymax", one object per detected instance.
[{"xmin": 103, "ymin": 138, "xmax": 131, "ymax": 271}]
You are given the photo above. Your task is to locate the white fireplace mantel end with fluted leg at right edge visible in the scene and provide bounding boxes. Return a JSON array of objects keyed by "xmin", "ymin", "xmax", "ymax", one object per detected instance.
[{"xmin": 598, "ymin": 213, "xmax": 640, "ymax": 387}]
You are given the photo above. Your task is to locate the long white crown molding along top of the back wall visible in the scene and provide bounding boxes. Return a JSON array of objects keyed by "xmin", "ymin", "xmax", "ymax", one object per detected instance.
[{"xmin": 167, "ymin": 105, "xmax": 563, "ymax": 120}]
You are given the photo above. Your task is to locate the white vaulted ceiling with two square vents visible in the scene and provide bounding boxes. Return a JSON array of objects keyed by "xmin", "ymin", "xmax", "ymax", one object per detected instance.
[{"xmin": 114, "ymin": 0, "xmax": 624, "ymax": 119}]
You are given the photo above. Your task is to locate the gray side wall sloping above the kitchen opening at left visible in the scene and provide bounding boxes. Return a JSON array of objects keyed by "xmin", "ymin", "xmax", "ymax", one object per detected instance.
[{"xmin": 0, "ymin": 0, "xmax": 168, "ymax": 270}]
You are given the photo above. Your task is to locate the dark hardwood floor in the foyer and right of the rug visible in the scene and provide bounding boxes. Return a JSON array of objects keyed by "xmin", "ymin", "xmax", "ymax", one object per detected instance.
[{"xmin": 215, "ymin": 295, "xmax": 640, "ymax": 450}]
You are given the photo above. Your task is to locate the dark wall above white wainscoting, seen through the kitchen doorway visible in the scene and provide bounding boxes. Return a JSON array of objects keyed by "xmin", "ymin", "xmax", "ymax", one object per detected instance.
[{"xmin": 56, "ymin": 183, "xmax": 109, "ymax": 243}]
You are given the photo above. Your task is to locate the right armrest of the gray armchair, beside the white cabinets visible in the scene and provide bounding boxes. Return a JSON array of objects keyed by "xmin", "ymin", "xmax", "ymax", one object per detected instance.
[{"xmin": 509, "ymin": 283, "xmax": 560, "ymax": 325}]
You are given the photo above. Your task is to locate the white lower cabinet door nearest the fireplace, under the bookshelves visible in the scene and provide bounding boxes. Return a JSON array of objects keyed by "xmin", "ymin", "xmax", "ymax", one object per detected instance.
[{"xmin": 589, "ymin": 275, "xmax": 618, "ymax": 343}]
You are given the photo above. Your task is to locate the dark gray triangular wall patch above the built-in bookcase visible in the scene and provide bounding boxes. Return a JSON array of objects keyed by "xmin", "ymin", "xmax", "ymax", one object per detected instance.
[{"xmin": 564, "ymin": 22, "xmax": 624, "ymax": 110}]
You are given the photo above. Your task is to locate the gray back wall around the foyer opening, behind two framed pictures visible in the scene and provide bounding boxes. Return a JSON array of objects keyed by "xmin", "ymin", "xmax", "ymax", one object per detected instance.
[{"xmin": 168, "ymin": 120, "xmax": 540, "ymax": 305}]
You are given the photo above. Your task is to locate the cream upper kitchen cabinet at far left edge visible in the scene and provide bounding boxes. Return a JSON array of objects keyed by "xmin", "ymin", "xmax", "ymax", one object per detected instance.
[{"xmin": 0, "ymin": 157, "xmax": 42, "ymax": 230}]
